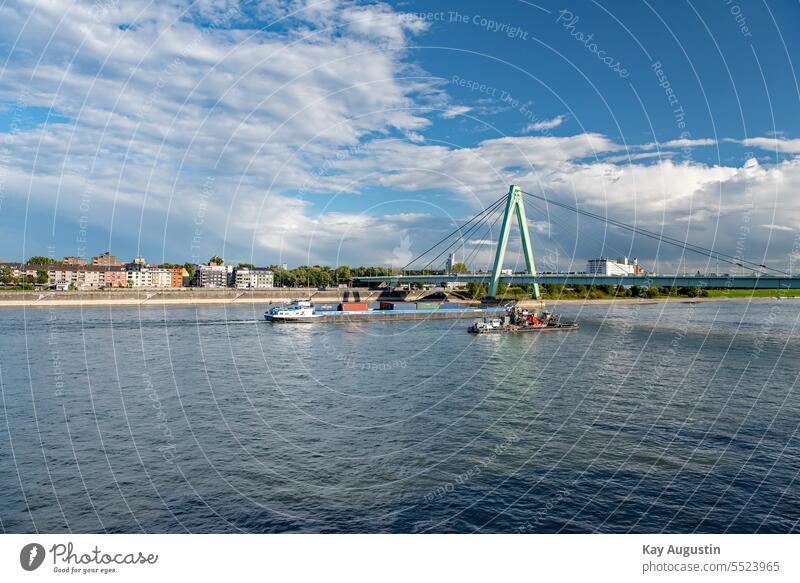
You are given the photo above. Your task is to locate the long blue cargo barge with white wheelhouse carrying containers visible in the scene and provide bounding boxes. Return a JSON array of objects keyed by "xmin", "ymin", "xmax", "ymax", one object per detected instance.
[{"xmin": 264, "ymin": 300, "xmax": 506, "ymax": 323}]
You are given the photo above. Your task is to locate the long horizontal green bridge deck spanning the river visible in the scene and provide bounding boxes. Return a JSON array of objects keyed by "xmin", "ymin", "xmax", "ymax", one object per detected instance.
[{"xmin": 357, "ymin": 273, "xmax": 800, "ymax": 289}]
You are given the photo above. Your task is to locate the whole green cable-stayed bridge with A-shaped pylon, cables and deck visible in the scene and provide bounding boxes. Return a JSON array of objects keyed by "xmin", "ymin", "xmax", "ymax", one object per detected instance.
[{"xmin": 359, "ymin": 185, "xmax": 800, "ymax": 299}]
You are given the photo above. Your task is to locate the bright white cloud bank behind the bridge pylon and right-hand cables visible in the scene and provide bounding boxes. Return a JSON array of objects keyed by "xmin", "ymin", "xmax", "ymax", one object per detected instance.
[{"xmin": 324, "ymin": 134, "xmax": 800, "ymax": 269}]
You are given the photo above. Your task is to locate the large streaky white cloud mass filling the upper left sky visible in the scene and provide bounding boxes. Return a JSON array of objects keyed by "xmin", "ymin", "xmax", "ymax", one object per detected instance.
[{"xmin": 0, "ymin": 0, "xmax": 442, "ymax": 264}]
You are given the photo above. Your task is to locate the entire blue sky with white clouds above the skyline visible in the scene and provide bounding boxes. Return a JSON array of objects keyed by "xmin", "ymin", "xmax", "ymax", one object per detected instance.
[{"xmin": 0, "ymin": 0, "xmax": 800, "ymax": 273}]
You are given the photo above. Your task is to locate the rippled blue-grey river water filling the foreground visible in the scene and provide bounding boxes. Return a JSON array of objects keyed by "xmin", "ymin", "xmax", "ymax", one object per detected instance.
[{"xmin": 0, "ymin": 300, "xmax": 800, "ymax": 533}]
